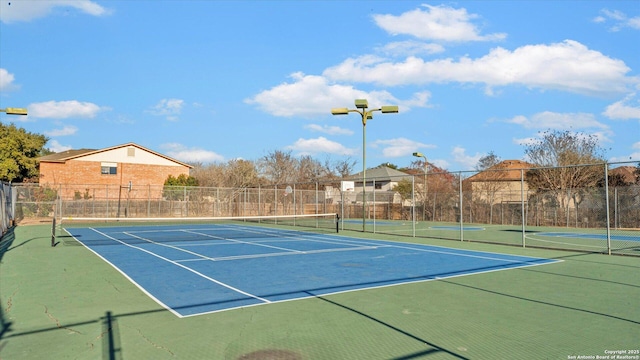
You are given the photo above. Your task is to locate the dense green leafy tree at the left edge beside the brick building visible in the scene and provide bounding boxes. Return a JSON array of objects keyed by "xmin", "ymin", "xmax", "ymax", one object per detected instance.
[{"xmin": 0, "ymin": 123, "xmax": 49, "ymax": 182}]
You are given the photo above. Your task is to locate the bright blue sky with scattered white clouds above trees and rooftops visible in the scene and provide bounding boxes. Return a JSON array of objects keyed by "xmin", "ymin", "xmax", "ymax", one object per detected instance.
[{"xmin": 0, "ymin": 0, "xmax": 640, "ymax": 171}]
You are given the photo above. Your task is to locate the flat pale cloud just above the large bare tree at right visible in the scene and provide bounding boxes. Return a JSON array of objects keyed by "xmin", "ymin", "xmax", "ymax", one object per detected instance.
[{"xmin": 507, "ymin": 111, "xmax": 609, "ymax": 130}]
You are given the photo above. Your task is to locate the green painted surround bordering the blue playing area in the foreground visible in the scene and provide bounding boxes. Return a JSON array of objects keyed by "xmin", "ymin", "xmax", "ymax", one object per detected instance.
[{"xmin": 0, "ymin": 227, "xmax": 640, "ymax": 360}]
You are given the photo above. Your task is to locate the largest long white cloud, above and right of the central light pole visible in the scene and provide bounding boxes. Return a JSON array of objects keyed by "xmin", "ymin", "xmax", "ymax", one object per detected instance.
[{"xmin": 323, "ymin": 40, "xmax": 640, "ymax": 95}]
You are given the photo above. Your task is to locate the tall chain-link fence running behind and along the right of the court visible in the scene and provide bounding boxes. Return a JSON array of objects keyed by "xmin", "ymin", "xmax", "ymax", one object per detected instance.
[{"xmin": 12, "ymin": 164, "xmax": 640, "ymax": 256}]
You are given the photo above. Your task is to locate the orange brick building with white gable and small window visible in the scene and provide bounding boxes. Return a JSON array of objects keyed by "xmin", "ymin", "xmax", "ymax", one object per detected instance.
[{"xmin": 38, "ymin": 143, "xmax": 192, "ymax": 198}]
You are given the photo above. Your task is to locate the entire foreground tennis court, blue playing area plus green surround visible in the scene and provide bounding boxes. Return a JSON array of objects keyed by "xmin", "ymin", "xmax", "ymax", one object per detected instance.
[{"xmin": 0, "ymin": 223, "xmax": 640, "ymax": 360}]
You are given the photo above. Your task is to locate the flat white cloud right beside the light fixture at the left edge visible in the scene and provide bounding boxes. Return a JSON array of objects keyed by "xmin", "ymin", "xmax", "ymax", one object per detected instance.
[{"xmin": 27, "ymin": 100, "xmax": 109, "ymax": 119}]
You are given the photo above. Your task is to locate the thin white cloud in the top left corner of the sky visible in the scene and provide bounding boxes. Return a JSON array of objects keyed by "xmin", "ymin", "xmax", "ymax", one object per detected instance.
[{"xmin": 0, "ymin": 0, "xmax": 111, "ymax": 24}]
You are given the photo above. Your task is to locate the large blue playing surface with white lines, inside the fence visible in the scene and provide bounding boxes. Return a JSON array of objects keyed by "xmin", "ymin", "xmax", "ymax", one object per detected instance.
[{"xmin": 66, "ymin": 224, "xmax": 557, "ymax": 317}]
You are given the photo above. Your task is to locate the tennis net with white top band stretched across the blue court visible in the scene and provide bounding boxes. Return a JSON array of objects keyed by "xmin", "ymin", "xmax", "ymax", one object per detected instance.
[{"xmin": 51, "ymin": 213, "xmax": 339, "ymax": 246}]
